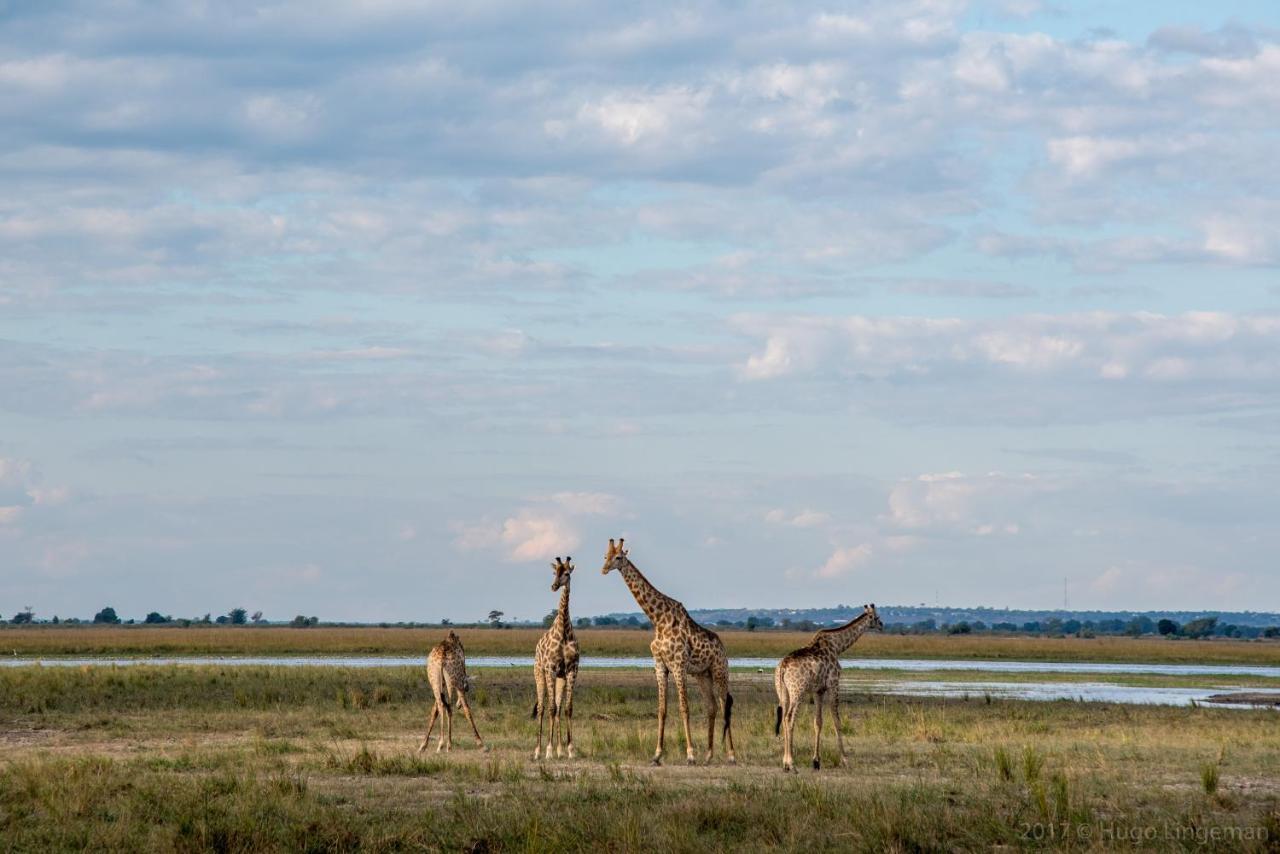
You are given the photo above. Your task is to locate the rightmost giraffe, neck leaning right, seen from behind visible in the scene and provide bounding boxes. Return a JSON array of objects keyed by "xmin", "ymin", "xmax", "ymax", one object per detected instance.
[{"xmin": 773, "ymin": 604, "xmax": 884, "ymax": 771}]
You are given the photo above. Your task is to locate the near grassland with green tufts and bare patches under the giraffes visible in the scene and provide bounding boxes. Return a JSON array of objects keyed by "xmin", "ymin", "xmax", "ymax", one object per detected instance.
[{"xmin": 0, "ymin": 666, "xmax": 1280, "ymax": 851}]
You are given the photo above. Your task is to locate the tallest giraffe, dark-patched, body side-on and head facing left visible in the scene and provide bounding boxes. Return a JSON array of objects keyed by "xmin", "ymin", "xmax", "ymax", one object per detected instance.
[{"xmin": 600, "ymin": 539, "xmax": 736, "ymax": 766}]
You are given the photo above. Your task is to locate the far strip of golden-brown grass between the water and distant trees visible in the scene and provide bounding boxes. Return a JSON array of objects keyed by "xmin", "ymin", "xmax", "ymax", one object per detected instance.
[{"xmin": 10, "ymin": 626, "xmax": 1280, "ymax": 665}]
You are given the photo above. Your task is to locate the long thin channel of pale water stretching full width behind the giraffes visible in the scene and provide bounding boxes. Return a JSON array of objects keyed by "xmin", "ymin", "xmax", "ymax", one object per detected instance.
[{"xmin": 0, "ymin": 656, "xmax": 1280, "ymax": 679}]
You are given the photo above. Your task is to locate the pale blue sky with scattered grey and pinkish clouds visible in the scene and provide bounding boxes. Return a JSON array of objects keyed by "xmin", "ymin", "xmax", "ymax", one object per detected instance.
[{"xmin": 0, "ymin": 0, "xmax": 1280, "ymax": 621}]
